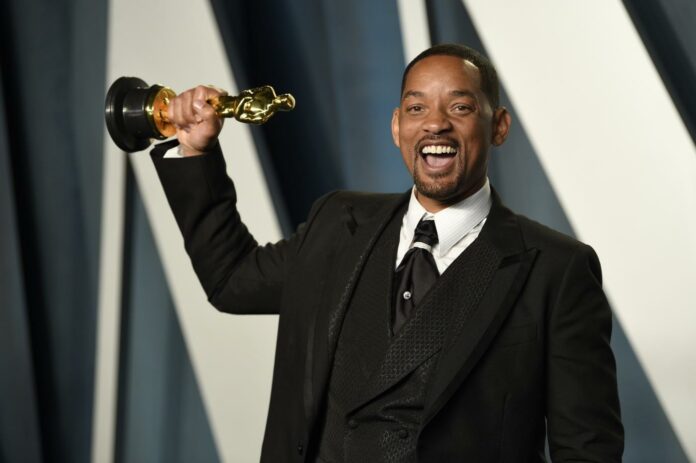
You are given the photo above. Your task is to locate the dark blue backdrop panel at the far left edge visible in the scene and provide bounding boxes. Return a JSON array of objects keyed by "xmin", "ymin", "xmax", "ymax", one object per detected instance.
[{"xmin": 0, "ymin": 0, "xmax": 106, "ymax": 463}]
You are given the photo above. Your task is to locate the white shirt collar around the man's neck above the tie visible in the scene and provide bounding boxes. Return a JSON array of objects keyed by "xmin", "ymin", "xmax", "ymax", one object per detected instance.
[{"xmin": 404, "ymin": 178, "xmax": 492, "ymax": 256}]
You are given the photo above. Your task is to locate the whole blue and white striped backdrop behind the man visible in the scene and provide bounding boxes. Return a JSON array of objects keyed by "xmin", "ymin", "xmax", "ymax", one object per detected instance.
[{"xmin": 0, "ymin": 0, "xmax": 696, "ymax": 463}]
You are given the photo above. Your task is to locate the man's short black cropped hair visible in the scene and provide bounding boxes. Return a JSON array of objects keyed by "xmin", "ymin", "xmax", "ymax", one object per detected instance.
[{"xmin": 401, "ymin": 43, "xmax": 500, "ymax": 109}]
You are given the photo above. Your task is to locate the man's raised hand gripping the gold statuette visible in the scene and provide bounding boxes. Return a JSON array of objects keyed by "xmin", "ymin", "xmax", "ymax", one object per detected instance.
[{"xmin": 168, "ymin": 85, "xmax": 226, "ymax": 156}]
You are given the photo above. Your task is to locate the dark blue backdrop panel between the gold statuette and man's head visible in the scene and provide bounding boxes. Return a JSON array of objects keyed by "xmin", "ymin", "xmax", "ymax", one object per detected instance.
[{"xmin": 211, "ymin": 0, "xmax": 410, "ymax": 233}]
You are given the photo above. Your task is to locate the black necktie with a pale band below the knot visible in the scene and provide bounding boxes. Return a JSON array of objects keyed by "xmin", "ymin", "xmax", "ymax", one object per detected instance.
[{"xmin": 392, "ymin": 219, "xmax": 440, "ymax": 334}]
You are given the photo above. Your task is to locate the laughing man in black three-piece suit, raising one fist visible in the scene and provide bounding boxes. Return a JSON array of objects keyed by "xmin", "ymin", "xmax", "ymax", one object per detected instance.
[{"xmin": 152, "ymin": 45, "xmax": 623, "ymax": 463}]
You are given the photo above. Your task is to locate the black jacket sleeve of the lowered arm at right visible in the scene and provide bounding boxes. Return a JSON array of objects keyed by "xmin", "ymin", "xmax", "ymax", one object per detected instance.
[{"xmin": 546, "ymin": 245, "xmax": 623, "ymax": 462}]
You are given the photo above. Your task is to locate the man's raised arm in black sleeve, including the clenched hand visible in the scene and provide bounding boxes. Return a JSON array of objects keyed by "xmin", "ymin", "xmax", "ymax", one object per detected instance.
[{"xmin": 151, "ymin": 87, "xmax": 303, "ymax": 314}]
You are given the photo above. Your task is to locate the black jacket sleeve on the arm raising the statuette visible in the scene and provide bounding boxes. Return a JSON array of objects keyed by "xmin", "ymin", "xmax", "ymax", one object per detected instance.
[{"xmin": 151, "ymin": 141, "xmax": 334, "ymax": 314}]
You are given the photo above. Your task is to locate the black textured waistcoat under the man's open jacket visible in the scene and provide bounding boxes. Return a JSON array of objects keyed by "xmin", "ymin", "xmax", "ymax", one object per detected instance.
[{"xmin": 319, "ymin": 210, "xmax": 446, "ymax": 463}]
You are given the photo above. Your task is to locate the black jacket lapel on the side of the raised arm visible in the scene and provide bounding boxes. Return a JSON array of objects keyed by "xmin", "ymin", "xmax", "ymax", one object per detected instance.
[{"xmin": 304, "ymin": 192, "xmax": 410, "ymax": 421}]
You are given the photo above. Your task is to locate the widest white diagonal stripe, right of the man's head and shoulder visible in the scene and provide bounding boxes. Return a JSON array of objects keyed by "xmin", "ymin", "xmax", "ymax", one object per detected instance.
[{"xmin": 465, "ymin": 0, "xmax": 696, "ymax": 459}]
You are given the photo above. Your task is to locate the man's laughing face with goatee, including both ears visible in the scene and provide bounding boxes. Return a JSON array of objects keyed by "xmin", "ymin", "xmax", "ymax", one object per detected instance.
[{"xmin": 392, "ymin": 55, "xmax": 510, "ymax": 212}]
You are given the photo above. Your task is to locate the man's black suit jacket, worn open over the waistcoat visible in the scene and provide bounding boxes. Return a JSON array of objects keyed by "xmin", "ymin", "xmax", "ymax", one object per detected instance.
[{"xmin": 152, "ymin": 144, "xmax": 623, "ymax": 463}]
